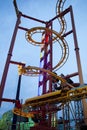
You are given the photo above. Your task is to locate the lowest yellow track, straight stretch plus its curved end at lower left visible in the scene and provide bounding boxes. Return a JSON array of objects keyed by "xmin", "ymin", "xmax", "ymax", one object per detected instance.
[{"xmin": 13, "ymin": 85, "xmax": 87, "ymax": 117}]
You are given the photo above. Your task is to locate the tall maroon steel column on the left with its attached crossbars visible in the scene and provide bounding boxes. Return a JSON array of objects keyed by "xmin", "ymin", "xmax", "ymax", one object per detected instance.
[{"xmin": 0, "ymin": 11, "xmax": 46, "ymax": 105}]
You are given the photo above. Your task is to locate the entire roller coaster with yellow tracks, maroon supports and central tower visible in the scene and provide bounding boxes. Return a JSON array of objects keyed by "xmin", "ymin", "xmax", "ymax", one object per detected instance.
[{"xmin": 0, "ymin": 0, "xmax": 87, "ymax": 130}]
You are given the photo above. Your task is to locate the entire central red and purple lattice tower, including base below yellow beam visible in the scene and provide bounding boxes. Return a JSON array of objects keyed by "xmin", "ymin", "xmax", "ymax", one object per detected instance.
[{"xmin": 38, "ymin": 22, "xmax": 52, "ymax": 126}]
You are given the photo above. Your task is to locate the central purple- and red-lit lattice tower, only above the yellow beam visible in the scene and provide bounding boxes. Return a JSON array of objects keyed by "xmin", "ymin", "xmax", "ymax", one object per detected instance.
[{"xmin": 38, "ymin": 23, "xmax": 52, "ymax": 95}]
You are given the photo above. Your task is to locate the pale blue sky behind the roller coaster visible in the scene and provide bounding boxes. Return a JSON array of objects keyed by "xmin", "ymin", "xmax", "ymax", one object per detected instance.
[{"xmin": 0, "ymin": 0, "xmax": 87, "ymax": 116}]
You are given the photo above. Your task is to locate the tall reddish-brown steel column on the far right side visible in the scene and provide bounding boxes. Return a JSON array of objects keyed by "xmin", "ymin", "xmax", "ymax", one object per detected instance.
[{"xmin": 70, "ymin": 6, "xmax": 87, "ymax": 125}]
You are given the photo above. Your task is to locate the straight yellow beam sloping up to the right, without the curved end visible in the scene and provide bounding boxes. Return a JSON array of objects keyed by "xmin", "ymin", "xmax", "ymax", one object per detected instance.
[{"xmin": 23, "ymin": 86, "xmax": 87, "ymax": 107}]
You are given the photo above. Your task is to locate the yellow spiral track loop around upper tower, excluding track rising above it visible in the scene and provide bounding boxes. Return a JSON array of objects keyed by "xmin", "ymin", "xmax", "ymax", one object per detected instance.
[{"xmin": 26, "ymin": 27, "xmax": 69, "ymax": 71}]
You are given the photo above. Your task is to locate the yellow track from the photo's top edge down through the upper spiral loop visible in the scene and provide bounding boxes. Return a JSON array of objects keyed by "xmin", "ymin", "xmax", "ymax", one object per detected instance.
[{"xmin": 25, "ymin": 0, "xmax": 69, "ymax": 71}]
